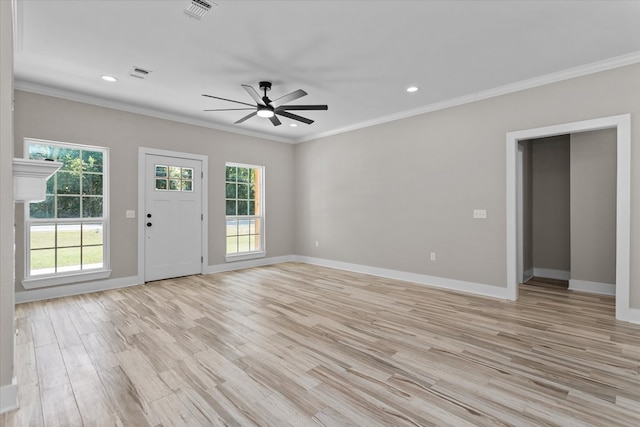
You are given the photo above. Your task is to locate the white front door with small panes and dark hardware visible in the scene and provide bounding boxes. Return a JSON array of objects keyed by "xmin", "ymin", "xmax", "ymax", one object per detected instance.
[{"xmin": 141, "ymin": 154, "xmax": 203, "ymax": 282}]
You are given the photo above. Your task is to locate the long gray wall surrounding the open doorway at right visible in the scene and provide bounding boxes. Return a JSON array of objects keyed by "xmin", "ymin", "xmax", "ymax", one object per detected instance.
[{"xmin": 295, "ymin": 64, "xmax": 640, "ymax": 307}]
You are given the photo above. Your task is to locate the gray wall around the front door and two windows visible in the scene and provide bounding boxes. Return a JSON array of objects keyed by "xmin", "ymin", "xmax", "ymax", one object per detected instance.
[{"xmin": 15, "ymin": 91, "xmax": 294, "ymax": 291}]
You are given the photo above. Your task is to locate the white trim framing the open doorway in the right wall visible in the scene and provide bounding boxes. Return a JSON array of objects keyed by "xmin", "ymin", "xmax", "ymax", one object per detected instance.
[{"xmin": 506, "ymin": 114, "xmax": 634, "ymax": 322}]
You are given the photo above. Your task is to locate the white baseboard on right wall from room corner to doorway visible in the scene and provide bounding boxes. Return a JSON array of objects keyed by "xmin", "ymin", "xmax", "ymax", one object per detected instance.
[{"xmin": 294, "ymin": 255, "xmax": 508, "ymax": 299}]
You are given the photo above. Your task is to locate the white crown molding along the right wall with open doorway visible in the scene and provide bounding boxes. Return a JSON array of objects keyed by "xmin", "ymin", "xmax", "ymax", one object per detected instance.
[{"xmin": 295, "ymin": 51, "xmax": 640, "ymax": 143}]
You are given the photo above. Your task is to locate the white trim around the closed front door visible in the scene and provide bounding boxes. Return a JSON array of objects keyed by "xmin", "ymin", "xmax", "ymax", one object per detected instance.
[{"xmin": 137, "ymin": 147, "xmax": 209, "ymax": 283}]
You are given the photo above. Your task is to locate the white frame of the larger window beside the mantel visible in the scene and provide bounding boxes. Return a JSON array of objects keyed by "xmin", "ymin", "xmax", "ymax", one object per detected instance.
[{"xmin": 22, "ymin": 138, "xmax": 111, "ymax": 289}]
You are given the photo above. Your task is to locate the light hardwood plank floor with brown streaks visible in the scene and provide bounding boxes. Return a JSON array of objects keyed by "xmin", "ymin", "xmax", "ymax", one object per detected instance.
[{"xmin": 0, "ymin": 263, "xmax": 640, "ymax": 427}]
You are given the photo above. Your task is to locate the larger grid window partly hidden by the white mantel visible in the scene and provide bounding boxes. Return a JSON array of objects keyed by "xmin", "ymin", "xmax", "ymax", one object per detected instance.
[{"xmin": 25, "ymin": 140, "xmax": 108, "ymax": 278}]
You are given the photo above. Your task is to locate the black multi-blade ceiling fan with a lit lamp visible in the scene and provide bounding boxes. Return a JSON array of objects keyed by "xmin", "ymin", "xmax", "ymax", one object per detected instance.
[{"xmin": 202, "ymin": 82, "xmax": 328, "ymax": 126}]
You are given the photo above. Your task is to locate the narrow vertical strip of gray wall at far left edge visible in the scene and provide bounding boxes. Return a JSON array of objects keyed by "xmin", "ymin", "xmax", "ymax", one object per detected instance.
[{"xmin": 0, "ymin": 1, "xmax": 15, "ymax": 394}]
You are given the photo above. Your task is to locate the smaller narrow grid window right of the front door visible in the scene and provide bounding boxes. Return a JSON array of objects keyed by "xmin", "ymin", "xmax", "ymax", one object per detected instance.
[{"xmin": 225, "ymin": 163, "xmax": 264, "ymax": 255}]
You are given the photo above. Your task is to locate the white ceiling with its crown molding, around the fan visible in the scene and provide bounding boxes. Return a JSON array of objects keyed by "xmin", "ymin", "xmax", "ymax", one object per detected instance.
[{"xmin": 15, "ymin": 0, "xmax": 640, "ymax": 142}]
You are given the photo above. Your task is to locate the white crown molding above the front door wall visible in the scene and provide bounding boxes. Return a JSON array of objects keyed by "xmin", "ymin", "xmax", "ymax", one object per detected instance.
[{"xmin": 14, "ymin": 79, "xmax": 295, "ymax": 144}]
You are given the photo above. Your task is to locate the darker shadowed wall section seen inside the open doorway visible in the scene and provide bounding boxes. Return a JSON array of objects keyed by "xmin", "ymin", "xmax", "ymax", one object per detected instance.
[{"xmin": 530, "ymin": 135, "xmax": 571, "ymax": 271}]
